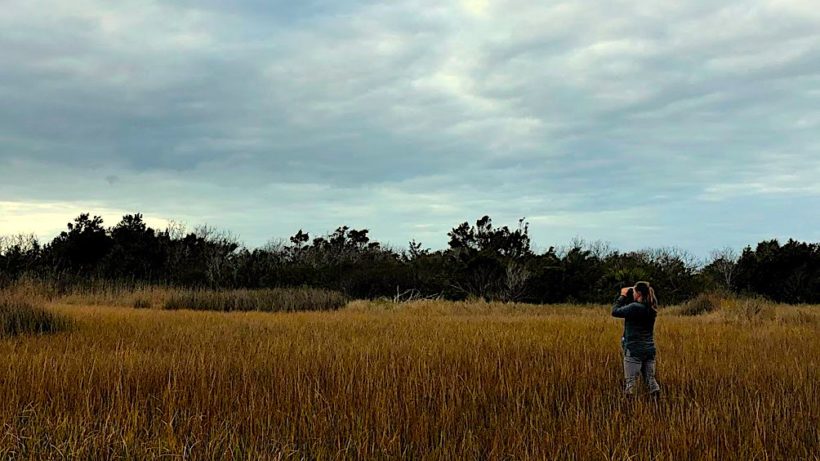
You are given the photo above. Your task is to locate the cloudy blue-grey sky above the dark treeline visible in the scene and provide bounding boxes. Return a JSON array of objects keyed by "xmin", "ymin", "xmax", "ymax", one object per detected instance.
[{"xmin": 0, "ymin": 0, "xmax": 820, "ymax": 256}]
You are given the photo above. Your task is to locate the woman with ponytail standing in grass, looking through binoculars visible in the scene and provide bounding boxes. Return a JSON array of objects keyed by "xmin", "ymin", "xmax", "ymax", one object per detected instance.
[{"xmin": 612, "ymin": 282, "xmax": 660, "ymax": 397}]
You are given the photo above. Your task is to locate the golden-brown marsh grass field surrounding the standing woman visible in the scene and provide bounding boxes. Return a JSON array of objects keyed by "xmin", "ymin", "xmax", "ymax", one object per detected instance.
[{"xmin": 0, "ymin": 292, "xmax": 820, "ymax": 460}]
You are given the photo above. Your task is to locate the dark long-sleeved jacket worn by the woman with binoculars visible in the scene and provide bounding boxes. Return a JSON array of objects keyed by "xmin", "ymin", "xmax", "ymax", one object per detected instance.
[{"xmin": 612, "ymin": 296, "xmax": 657, "ymax": 360}]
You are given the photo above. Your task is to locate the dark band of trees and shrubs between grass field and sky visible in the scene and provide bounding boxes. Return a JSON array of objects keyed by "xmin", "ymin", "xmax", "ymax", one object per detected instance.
[{"xmin": 0, "ymin": 214, "xmax": 820, "ymax": 304}]
